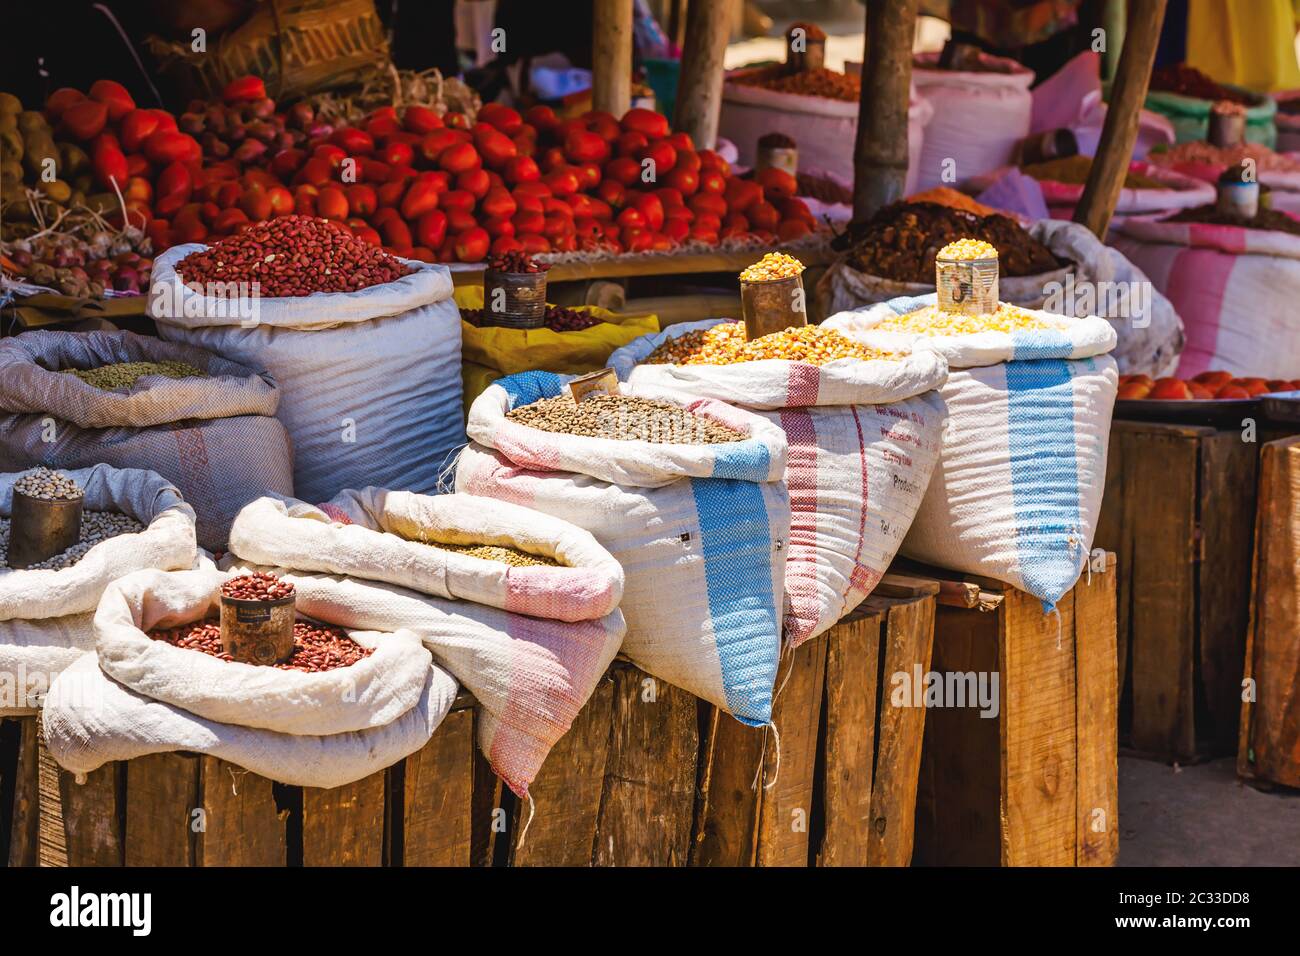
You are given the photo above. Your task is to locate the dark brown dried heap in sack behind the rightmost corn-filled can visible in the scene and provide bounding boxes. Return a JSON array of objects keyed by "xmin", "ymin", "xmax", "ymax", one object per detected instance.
[{"xmin": 848, "ymin": 202, "xmax": 1062, "ymax": 285}]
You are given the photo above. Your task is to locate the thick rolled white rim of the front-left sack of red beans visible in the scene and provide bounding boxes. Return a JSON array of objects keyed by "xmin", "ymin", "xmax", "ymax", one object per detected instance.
[{"xmin": 95, "ymin": 568, "xmax": 429, "ymax": 735}]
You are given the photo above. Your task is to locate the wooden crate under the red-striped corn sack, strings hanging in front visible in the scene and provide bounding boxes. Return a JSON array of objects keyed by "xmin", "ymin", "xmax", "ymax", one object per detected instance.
[{"xmin": 692, "ymin": 581, "xmax": 939, "ymax": 866}]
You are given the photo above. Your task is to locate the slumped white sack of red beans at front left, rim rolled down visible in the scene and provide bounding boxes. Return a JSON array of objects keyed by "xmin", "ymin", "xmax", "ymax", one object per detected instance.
[{"xmin": 43, "ymin": 564, "xmax": 458, "ymax": 787}]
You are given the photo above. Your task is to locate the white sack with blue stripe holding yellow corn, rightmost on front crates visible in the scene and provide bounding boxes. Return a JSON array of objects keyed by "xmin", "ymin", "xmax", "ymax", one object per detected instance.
[{"xmin": 826, "ymin": 295, "xmax": 1119, "ymax": 610}]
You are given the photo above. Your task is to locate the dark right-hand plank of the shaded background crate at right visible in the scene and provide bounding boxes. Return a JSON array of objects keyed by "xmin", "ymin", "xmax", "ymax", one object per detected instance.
[{"xmin": 1195, "ymin": 429, "xmax": 1258, "ymax": 756}]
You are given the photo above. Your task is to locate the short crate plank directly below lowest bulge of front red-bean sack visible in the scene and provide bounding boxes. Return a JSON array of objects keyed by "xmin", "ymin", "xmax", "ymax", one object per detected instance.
[{"xmin": 303, "ymin": 770, "xmax": 385, "ymax": 866}]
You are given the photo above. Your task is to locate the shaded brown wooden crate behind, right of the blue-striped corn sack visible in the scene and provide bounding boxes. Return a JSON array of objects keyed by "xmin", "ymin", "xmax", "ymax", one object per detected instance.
[{"xmin": 1096, "ymin": 421, "xmax": 1260, "ymax": 762}]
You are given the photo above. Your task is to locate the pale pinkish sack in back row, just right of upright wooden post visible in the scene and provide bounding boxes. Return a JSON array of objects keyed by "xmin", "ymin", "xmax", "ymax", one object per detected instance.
[{"xmin": 911, "ymin": 53, "xmax": 1034, "ymax": 190}]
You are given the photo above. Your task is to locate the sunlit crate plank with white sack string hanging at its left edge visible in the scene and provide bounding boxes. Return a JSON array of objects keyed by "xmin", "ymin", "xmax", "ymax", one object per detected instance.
[{"xmin": 757, "ymin": 633, "xmax": 828, "ymax": 866}]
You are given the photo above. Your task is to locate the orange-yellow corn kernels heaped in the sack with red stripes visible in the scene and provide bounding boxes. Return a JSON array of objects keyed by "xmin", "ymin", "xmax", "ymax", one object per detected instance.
[{"xmin": 646, "ymin": 323, "xmax": 902, "ymax": 365}]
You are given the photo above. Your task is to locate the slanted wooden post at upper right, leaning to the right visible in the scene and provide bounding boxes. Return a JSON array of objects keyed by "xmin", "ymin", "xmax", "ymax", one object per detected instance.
[{"xmin": 1076, "ymin": 0, "xmax": 1165, "ymax": 238}]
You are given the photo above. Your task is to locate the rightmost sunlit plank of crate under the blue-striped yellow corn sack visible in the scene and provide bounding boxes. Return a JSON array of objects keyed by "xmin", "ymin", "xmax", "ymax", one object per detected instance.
[{"xmin": 1074, "ymin": 562, "xmax": 1119, "ymax": 866}]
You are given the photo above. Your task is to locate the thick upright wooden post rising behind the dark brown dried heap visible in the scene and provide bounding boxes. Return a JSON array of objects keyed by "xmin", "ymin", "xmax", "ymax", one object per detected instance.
[{"xmin": 853, "ymin": 0, "xmax": 917, "ymax": 222}]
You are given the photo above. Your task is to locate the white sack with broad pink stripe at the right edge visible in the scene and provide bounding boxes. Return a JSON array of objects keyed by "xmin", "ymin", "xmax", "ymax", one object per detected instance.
[{"xmin": 1112, "ymin": 220, "xmax": 1300, "ymax": 378}]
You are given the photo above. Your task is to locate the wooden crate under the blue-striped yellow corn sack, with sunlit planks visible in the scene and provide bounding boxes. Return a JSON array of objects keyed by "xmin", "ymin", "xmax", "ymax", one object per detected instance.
[{"xmin": 915, "ymin": 555, "xmax": 1119, "ymax": 866}]
